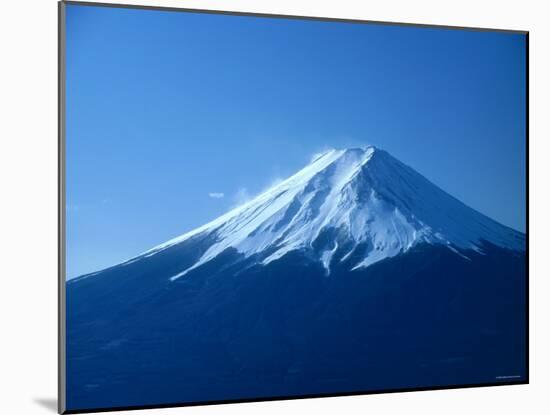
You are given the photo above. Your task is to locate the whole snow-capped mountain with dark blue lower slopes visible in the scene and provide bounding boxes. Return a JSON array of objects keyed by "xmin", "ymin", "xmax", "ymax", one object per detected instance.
[{"xmin": 67, "ymin": 146, "xmax": 526, "ymax": 409}]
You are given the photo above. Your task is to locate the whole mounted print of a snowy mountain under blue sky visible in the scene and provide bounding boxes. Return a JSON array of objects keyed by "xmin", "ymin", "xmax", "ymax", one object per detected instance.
[{"xmin": 59, "ymin": 2, "xmax": 528, "ymax": 413}]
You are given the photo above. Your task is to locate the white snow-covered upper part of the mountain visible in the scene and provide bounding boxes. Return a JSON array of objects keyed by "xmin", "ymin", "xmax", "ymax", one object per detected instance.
[{"xmin": 135, "ymin": 146, "xmax": 525, "ymax": 280}]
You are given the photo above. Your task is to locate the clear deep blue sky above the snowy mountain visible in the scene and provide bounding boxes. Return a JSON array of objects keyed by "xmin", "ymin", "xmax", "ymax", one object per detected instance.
[{"xmin": 67, "ymin": 5, "xmax": 526, "ymax": 277}]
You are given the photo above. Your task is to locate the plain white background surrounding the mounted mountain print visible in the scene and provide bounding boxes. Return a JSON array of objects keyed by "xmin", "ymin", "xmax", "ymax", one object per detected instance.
[{"xmin": 0, "ymin": 0, "xmax": 550, "ymax": 415}]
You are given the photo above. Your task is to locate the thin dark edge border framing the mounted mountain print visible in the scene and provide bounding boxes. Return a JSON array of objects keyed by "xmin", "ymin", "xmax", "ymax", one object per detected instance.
[{"xmin": 58, "ymin": 1, "xmax": 529, "ymax": 414}]
